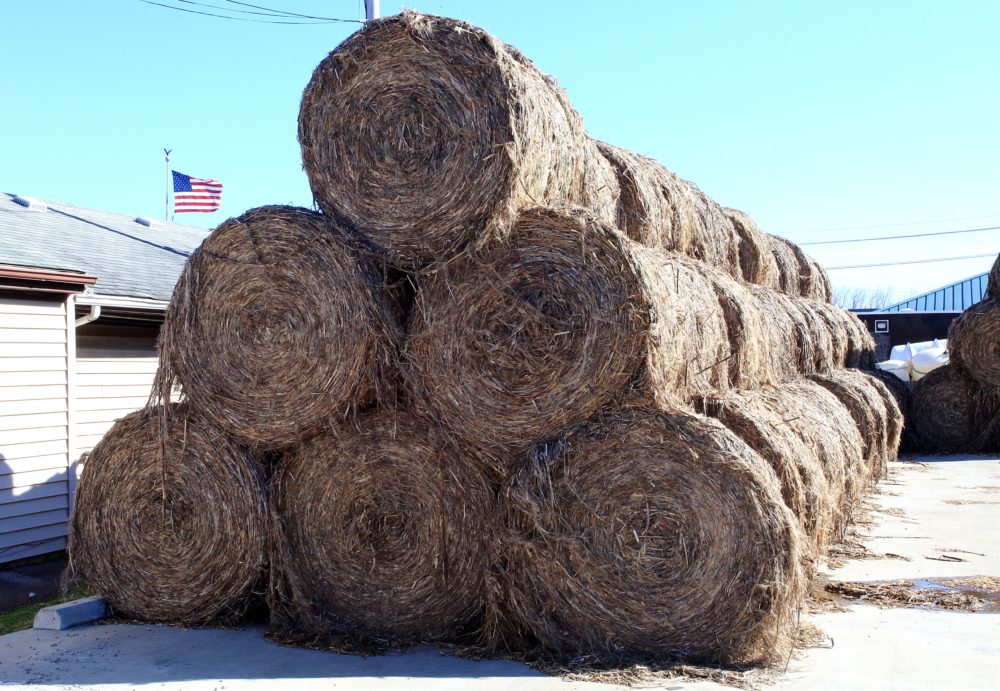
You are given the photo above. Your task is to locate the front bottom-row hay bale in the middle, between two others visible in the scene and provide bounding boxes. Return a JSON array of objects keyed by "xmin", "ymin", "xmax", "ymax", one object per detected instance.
[{"xmin": 270, "ymin": 411, "xmax": 496, "ymax": 649}]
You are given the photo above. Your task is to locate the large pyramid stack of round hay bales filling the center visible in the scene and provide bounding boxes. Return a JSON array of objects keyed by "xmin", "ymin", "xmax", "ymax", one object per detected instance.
[{"xmin": 70, "ymin": 13, "xmax": 902, "ymax": 662}]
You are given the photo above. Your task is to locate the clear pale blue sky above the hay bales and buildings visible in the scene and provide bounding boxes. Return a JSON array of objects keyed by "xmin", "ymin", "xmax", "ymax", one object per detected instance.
[{"xmin": 0, "ymin": 0, "xmax": 1000, "ymax": 298}]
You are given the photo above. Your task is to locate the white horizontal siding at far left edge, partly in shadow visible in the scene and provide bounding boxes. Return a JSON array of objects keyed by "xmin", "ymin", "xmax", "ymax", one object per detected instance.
[{"xmin": 0, "ymin": 296, "xmax": 75, "ymax": 563}]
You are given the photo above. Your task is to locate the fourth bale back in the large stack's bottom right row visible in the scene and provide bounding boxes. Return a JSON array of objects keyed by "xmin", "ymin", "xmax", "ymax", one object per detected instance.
[{"xmin": 810, "ymin": 369, "xmax": 889, "ymax": 483}]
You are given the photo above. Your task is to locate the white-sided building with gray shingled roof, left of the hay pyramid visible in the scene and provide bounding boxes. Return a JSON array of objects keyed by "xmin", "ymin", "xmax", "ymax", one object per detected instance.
[{"xmin": 0, "ymin": 194, "xmax": 207, "ymax": 563}]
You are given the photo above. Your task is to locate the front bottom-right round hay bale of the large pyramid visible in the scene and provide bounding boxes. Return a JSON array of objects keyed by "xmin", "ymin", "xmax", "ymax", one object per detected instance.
[{"xmin": 492, "ymin": 409, "xmax": 802, "ymax": 662}]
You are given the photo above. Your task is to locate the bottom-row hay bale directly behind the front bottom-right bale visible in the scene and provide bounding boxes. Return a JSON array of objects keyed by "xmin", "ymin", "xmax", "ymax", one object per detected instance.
[{"xmin": 697, "ymin": 387, "xmax": 832, "ymax": 557}]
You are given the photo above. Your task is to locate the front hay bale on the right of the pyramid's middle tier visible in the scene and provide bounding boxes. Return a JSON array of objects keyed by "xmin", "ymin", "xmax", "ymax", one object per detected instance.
[{"xmin": 404, "ymin": 209, "xmax": 731, "ymax": 450}]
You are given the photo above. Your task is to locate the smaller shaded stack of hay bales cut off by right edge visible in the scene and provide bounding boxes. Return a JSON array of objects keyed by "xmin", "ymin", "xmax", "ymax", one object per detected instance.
[{"xmin": 907, "ymin": 255, "xmax": 1000, "ymax": 453}]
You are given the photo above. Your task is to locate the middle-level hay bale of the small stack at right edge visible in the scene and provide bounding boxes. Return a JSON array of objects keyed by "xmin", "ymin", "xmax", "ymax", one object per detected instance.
[{"xmin": 948, "ymin": 299, "xmax": 1000, "ymax": 386}]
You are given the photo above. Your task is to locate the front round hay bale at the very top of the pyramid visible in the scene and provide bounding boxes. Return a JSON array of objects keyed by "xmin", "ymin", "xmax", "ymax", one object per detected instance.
[{"xmin": 299, "ymin": 12, "xmax": 618, "ymax": 268}]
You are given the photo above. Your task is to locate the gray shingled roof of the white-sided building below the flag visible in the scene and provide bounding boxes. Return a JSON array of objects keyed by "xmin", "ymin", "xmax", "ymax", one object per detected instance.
[{"xmin": 0, "ymin": 193, "xmax": 209, "ymax": 301}]
